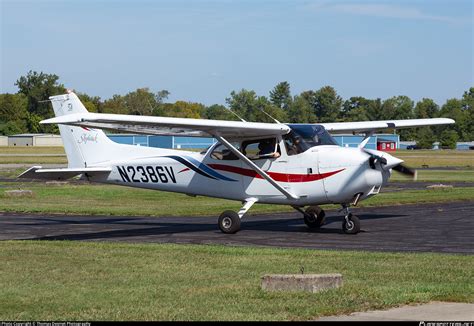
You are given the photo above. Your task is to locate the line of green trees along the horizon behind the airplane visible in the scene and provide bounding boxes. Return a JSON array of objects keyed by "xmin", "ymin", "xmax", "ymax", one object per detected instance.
[{"xmin": 0, "ymin": 71, "xmax": 474, "ymax": 148}]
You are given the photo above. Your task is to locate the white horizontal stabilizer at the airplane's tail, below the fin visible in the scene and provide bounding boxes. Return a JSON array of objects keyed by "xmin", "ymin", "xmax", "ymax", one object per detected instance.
[{"xmin": 18, "ymin": 166, "xmax": 112, "ymax": 180}]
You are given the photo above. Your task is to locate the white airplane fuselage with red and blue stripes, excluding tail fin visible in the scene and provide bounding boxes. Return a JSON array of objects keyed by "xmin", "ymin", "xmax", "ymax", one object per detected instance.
[{"xmin": 90, "ymin": 146, "xmax": 390, "ymax": 206}]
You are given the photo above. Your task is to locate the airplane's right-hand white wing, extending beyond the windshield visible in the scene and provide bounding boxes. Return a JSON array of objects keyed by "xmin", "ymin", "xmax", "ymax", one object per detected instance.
[{"xmin": 320, "ymin": 118, "xmax": 455, "ymax": 134}]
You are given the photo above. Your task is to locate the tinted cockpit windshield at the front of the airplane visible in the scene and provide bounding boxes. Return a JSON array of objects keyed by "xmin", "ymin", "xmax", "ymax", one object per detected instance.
[{"xmin": 286, "ymin": 124, "xmax": 338, "ymax": 152}]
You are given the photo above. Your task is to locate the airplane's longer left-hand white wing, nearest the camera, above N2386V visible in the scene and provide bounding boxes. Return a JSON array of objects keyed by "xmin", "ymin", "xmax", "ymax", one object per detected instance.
[{"xmin": 41, "ymin": 113, "xmax": 290, "ymax": 139}]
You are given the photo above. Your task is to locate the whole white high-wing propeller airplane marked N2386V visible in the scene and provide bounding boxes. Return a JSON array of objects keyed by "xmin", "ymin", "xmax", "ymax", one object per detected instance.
[{"xmin": 20, "ymin": 91, "xmax": 454, "ymax": 234}]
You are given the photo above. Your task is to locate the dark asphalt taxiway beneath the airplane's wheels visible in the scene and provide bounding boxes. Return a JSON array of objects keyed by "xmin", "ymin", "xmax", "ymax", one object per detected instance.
[{"xmin": 0, "ymin": 201, "xmax": 474, "ymax": 254}]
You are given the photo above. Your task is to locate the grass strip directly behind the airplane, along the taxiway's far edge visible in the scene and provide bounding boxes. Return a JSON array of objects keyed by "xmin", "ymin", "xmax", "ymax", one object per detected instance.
[{"xmin": 0, "ymin": 183, "xmax": 474, "ymax": 216}]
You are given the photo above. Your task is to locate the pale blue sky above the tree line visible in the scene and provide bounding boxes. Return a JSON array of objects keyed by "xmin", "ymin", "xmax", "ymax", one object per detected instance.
[{"xmin": 0, "ymin": 0, "xmax": 474, "ymax": 105}]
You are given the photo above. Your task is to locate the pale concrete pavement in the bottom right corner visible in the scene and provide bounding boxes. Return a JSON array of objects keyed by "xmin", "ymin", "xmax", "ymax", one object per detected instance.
[{"xmin": 318, "ymin": 302, "xmax": 474, "ymax": 321}]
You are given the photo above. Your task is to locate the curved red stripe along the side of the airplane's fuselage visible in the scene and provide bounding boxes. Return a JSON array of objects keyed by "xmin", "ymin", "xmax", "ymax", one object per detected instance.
[{"xmin": 208, "ymin": 164, "xmax": 345, "ymax": 182}]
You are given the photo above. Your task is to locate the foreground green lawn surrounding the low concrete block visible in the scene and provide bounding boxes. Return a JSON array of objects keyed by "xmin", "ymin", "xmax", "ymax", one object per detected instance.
[{"xmin": 0, "ymin": 241, "xmax": 474, "ymax": 320}]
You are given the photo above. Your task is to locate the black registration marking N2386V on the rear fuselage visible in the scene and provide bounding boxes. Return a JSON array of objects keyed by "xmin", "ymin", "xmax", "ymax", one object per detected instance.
[{"xmin": 117, "ymin": 165, "xmax": 176, "ymax": 183}]
